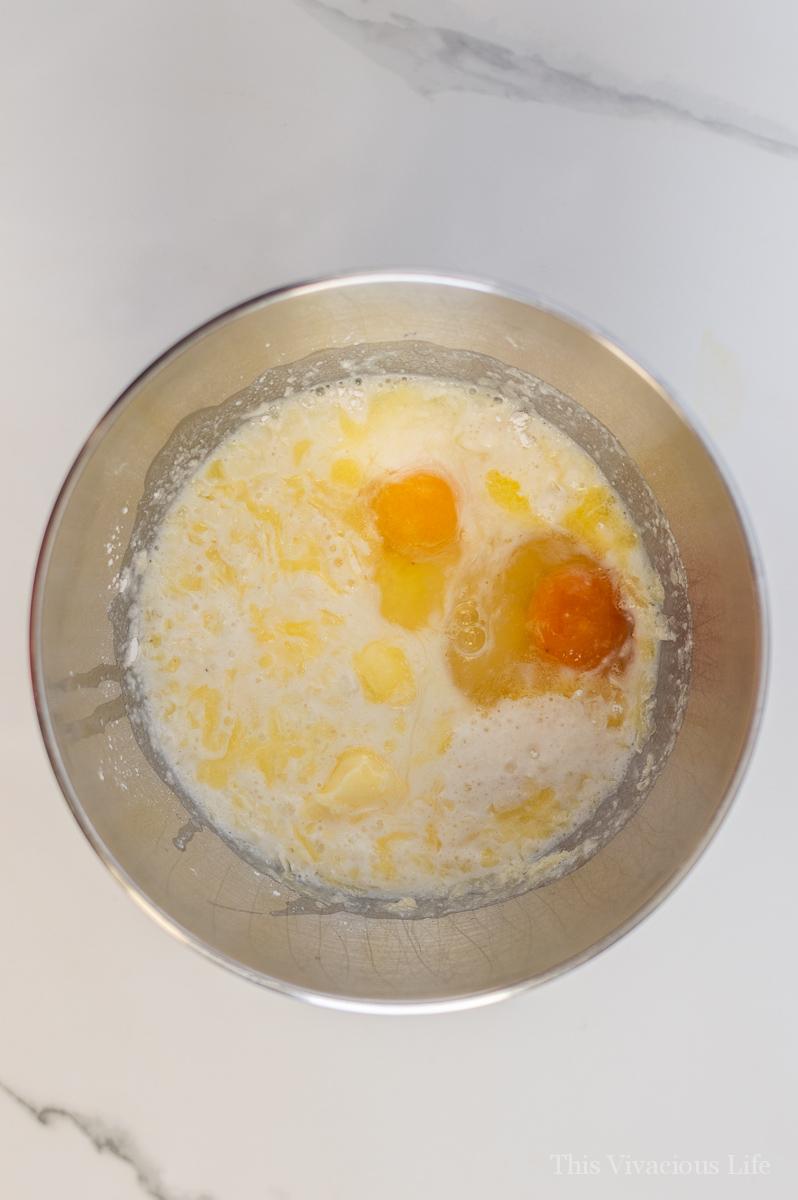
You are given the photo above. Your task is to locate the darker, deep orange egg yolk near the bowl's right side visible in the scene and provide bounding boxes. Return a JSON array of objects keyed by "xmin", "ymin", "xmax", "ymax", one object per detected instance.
[{"xmin": 527, "ymin": 563, "xmax": 631, "ymax": 671}]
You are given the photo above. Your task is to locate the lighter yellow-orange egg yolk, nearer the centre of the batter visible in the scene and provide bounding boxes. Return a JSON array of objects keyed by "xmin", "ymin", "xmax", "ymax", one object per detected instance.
[{"xmin": 371, "ymin": 470, "xmax": 457, "ymax": 560}]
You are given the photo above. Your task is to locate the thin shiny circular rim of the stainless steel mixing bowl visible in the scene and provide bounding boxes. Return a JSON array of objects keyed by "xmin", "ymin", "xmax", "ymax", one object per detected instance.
[{"xmin": 28, "ymin": 269, "xmax": 770, "ymax": 1014}]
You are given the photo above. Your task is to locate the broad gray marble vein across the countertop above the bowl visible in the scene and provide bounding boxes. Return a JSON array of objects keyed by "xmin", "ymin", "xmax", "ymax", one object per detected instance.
[{"xmin": 296, "ymin": 0, "xmax": 798, "ymax": 158}]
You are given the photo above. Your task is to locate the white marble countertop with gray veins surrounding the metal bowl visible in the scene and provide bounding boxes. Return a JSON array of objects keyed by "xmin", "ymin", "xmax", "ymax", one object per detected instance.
[{"xmin": 0, "ymin": 0, "xmax": 798, "ymax": 1200}]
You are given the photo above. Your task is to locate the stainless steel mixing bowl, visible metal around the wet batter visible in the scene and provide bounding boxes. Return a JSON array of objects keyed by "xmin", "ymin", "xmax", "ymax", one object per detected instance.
[{"xmin": 31, "ymin": 272, "xmax": 764, "ymax": 1010}]
